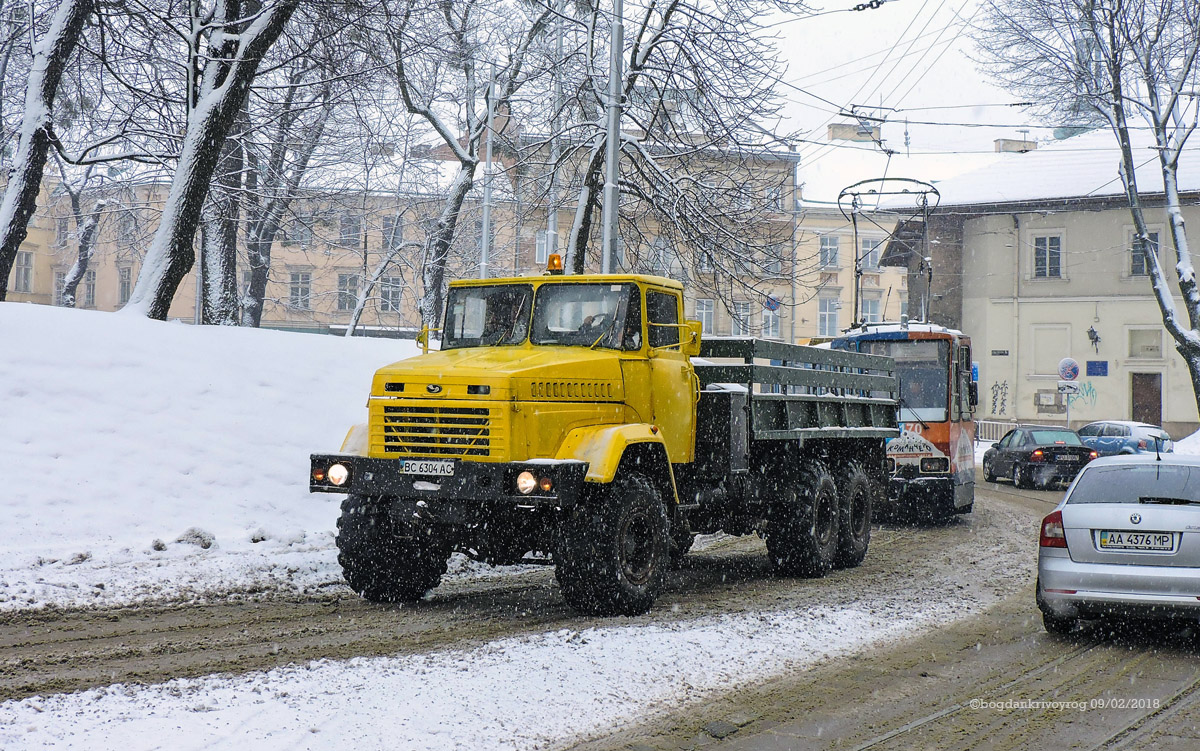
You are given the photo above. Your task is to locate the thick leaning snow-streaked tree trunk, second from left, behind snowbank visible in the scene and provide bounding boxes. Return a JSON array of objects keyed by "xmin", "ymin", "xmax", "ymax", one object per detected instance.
[{"xmin": 122, "ymin": 0, "xmax": 299, "ymax": 320}]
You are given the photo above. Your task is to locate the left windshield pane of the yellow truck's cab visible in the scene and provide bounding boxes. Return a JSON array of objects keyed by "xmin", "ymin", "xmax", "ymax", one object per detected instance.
[{"xmin": 442, "ymin": 284, "xmax": 533, "ymax": 349}]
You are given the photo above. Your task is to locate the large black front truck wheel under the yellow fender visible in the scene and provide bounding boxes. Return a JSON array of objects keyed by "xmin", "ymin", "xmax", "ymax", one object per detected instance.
[{"xmin": 554, "ymin": 471, "xmax": 671, "ymax": 615}]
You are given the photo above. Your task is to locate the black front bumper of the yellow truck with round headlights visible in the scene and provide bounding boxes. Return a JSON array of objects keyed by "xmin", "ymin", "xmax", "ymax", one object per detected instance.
[{"xmin": 308, "ymin": 453, "xmax": 588, "ymax": 509}]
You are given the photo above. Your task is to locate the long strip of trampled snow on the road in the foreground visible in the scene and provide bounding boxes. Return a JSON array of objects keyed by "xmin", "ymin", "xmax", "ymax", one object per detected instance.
[{"xmin": 0, "ymin": 588, "xmax": 964, "ymax": 751}]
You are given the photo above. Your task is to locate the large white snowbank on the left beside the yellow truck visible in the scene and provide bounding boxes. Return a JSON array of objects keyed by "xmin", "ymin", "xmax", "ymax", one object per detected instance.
[{"xmin": 0, "ymin": 302, "xmax": 416, "ymax": 609}]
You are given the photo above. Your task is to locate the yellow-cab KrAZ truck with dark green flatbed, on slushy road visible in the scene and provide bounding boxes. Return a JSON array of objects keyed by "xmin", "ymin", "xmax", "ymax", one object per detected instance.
[{"xmin": 310, "ymin": 275, "xmax": 898, "ymax": 614}]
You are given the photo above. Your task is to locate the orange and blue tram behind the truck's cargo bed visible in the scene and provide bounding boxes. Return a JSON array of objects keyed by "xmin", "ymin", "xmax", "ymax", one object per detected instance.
[{"xmin": 829, "ymin": 322, "xmax": 979, "ymax": 519}]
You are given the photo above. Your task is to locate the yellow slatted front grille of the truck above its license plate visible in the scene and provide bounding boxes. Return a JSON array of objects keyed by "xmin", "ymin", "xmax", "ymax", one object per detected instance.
[{"xmin": 383, "ymin": 404, "xmax": 492, "ymax": 457}]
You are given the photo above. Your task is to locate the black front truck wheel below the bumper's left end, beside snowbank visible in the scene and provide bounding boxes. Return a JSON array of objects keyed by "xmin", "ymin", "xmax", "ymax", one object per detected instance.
[{"xmin": 337, "ymin": 495, "xmax": 450, "ymax": 602}]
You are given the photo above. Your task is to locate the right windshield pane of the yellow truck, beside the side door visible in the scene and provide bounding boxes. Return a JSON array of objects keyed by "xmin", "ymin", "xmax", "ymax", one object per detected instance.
[{"xmin": 529, "ymin": 283, "xmax": 642, "ymax": 350}]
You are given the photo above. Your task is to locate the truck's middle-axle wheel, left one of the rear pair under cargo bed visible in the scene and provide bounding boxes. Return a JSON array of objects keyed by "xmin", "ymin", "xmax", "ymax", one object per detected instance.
[{"xmin": 766, "ymin": 462, "xmax": 839, "ymax": 577}]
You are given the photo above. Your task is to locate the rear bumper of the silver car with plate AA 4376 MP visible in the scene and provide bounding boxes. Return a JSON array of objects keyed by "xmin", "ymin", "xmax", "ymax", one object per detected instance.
[{"xmin": 1038, "ymin": 548, "xmax": 1200, "ymax": 618}]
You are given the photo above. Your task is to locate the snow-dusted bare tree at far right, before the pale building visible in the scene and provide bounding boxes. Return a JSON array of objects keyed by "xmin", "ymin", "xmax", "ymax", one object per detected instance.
[{"xmin": 979, "ymin": 0, "xmax": 1200, "ymax": 405}]
